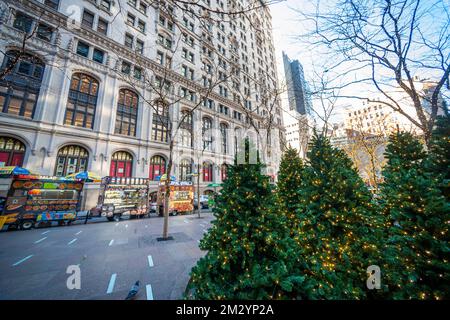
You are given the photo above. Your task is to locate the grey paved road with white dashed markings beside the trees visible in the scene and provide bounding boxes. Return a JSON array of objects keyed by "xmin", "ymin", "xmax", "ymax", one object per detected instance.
[{"xmin": 0, "ymin": 213, "xmax": 213, "ymax": 300}]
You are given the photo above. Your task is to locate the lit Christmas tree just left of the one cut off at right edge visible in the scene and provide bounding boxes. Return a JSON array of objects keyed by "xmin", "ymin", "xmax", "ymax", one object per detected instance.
[{"xmin": 381, "ymin": 133, "xmax": 450, "ymax": 299}]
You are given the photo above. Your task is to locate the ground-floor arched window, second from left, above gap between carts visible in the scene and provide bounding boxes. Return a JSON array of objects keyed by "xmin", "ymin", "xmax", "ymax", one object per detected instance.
[{"xmin": 55, "ymin": 145, "xmax": 89, "ymax": 177}]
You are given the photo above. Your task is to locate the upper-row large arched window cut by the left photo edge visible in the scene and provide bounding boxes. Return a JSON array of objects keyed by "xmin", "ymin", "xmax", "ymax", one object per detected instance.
[{"xmin": 0, "ymin": 50, "xmax": 45, "ymax": 118}]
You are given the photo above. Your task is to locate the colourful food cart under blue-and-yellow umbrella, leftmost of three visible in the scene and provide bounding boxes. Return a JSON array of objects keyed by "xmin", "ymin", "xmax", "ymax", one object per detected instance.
[{"xmin": 0, "ymin": 167, "xmax": 83, "ymax": 230}]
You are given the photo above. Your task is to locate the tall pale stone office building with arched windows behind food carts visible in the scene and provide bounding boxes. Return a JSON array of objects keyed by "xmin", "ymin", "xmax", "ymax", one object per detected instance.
[{"xmin": 0, "ymin": 0, "xmax": 282, "ymax": 192}]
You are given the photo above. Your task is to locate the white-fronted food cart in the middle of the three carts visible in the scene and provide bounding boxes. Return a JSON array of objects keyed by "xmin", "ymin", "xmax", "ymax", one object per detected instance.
[{"xmin": 98, "ymin": 177, "xmax": 149, "ymax": 221}]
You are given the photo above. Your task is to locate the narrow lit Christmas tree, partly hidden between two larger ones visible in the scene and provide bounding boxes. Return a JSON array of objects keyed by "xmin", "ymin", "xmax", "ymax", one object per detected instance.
[{"xmin": 276, "ymin": 147, "xmax": 303, "ymax": 236}]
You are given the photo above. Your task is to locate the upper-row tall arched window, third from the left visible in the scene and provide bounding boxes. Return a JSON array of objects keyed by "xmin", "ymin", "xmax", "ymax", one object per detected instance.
[{"xmin": 114, "ymin": 89, "xmax": 139, "ymax": 136}]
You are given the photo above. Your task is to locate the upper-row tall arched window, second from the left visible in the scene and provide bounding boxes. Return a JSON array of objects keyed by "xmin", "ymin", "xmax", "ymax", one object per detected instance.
[{"xmin": 64, "ymin": 73, "xmax": 98, "ymax": 129}]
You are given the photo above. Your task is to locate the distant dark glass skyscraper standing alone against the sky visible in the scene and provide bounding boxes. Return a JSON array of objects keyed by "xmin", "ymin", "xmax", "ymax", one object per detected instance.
[{"xmin": 283, "ymin": 52, "xmax": 312, "ymax": 115}]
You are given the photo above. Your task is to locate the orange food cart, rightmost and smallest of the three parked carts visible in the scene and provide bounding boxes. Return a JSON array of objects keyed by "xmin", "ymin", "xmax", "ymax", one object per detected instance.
[{"xmin": 157, "ymin": 181, "xmax": 194, "ymax": 216}]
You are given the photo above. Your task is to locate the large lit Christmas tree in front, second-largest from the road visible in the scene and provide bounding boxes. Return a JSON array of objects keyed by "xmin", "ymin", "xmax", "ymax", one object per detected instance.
[{"xmin": 296, "ymin": 135, "xmax": 383, "ymax": 299}]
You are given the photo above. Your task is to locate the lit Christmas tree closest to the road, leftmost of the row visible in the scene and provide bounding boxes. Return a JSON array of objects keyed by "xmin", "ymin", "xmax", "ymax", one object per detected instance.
[{"xmin": 188, "ymin": 140, "xmax": 302, "ymax": 299}]
